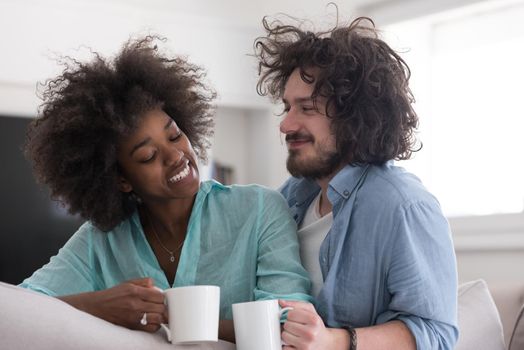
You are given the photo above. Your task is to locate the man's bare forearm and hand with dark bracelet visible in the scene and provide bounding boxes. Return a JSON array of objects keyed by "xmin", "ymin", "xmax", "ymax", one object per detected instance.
[{"xmin": 280, "ymin": 300, "xmax": 417, "ymax": 350}]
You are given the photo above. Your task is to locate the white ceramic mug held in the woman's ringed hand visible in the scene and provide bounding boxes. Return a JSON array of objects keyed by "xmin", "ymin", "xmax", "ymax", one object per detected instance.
[{"xmin": 162, "ymin": 286, "xmax": 220, "ymax": 344}]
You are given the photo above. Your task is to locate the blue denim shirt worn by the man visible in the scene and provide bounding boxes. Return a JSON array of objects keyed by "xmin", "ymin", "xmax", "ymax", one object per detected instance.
[{"xmin": 281, "ymin": 162, "xmax": 458, "ymax": 350}]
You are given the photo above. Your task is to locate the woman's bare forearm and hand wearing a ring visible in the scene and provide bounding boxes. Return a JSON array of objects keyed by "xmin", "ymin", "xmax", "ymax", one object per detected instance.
[{"xmin": 59, "ymin": 278, "xmax": 167, "ymax": 332}]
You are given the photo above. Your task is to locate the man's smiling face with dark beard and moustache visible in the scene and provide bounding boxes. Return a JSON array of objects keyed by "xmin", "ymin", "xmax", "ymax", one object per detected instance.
[{"xmin": 280, "ymin": 68, "xmax": 342, "ymax": 180}]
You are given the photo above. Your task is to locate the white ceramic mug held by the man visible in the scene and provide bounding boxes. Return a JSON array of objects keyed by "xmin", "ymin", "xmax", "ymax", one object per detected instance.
[{"xmin": 233, "ymin": 300, "xmax": 292, "ymax": 350}]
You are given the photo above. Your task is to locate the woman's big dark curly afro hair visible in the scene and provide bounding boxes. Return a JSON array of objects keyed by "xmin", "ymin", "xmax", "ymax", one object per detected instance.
[{"xmin": 24, "ymin": 36, "xmax": 215, "ymax": 231}]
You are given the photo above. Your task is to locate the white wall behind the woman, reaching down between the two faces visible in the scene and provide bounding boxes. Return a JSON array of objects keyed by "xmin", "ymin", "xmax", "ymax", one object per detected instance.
[{"xmin": 0, "ymin": 0, "xmax": 285, "ymax": 187}]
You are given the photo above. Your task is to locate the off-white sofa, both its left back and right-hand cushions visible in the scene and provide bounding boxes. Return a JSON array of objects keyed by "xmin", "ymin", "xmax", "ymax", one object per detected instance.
[{"xmin": 0, "ymin": 280, "xmax": 524, "ymax": 350}]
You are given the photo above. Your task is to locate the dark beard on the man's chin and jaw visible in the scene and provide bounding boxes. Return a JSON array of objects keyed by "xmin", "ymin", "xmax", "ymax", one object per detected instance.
[{"xmin": 286, "ymin": 147, "xmax": 342, "ymax": 180}]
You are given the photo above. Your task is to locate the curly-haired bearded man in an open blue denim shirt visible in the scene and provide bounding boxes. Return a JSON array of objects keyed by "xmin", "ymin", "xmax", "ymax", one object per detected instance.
[{"xmin": 255, "ymin": 18, "xmax": 458, "ymax": 350}]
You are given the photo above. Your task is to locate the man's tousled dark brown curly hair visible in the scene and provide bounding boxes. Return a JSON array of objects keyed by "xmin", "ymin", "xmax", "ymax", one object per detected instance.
[{"xmin": 254, "ymin": 17, "xmax": 420, "ymax": 164}]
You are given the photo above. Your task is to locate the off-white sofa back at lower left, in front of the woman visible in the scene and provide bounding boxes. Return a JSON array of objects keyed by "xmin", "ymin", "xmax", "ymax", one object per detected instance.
[{"xmin": 0, "ymin": 282, "xmax": 235, "ymax": 350}]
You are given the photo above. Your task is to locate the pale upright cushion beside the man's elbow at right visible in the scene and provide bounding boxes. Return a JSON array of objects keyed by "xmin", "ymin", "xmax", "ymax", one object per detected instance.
[{"xmin": 455, "ymin": 280, "xmax": 505, "ymax": 350}]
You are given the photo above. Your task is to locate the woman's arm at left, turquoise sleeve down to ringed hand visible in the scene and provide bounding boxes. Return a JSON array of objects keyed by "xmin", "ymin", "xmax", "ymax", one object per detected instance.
[{"xmin": 20, "ymin": 223, "xmax": 167, "ymax": 331}]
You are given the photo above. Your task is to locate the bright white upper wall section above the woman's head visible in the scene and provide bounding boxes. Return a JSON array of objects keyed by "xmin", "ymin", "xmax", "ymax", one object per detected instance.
[{"xmin": 0, "ymin": 0, "xmax": 267, "ymax": 114}]
